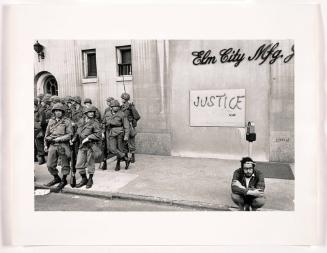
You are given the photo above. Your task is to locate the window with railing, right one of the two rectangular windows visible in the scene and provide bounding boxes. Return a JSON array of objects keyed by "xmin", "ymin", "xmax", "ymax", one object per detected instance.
[{"xmin": 117, "ymin": 46, "xmax": 132, "ymax": 76}]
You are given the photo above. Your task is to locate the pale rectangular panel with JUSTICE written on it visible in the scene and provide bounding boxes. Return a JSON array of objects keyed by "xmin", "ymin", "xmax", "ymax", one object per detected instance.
[{"xmin": 190, "ymin": 89, "xmax": 245, "ymax": 127}]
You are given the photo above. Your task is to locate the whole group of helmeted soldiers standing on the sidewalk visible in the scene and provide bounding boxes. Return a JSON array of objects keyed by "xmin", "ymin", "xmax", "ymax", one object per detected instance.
[{"xmin": 34, "ymin": 93, "xmax": 140, "ymax": 192}]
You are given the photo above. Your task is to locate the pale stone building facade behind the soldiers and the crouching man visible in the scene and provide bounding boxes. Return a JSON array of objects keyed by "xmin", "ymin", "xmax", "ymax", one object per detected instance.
[{"xmin": 34, "ymin": 40, "xmax": 294, "ymax": 162}]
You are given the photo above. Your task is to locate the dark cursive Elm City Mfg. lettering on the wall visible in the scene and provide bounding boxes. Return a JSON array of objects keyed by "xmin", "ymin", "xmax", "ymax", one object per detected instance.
[{"xmin": 192, "ymin": 42, "xmax": 294, "ymax": 67}]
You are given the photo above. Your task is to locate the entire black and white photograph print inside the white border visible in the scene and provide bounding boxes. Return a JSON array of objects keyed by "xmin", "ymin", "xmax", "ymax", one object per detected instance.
[{"xmin": 34, "ymin": 38, "xmax": 297, "ymax": 212}]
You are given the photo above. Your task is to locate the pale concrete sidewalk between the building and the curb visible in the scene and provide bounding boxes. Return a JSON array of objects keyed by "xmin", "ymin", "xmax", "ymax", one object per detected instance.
[{"xmin": 34, "ymin": 154, "xmax": 294, "ymax": 211}]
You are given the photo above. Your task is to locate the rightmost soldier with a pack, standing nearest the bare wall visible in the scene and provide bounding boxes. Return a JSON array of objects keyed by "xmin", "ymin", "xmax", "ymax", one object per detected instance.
[{"xmin": 121, "ymin": 93, "xmax": 141, "ymax": 163}]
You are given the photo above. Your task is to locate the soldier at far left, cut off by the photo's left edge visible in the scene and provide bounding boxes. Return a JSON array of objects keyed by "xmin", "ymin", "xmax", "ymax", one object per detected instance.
[{"xmin": 34, "ymin": 99, "xmax": 46, "ymax": 165}]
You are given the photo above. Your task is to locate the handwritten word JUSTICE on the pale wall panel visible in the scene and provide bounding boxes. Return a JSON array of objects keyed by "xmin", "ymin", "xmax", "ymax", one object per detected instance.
[{"xmin": 193, "ymin": 93, "xmax": 245, "ymax": 110}]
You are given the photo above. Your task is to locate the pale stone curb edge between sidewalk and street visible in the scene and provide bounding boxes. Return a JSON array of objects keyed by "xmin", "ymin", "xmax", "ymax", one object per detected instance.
[{"xmin": 34, "ymin": 183, "xmax": 233, "ymax": 211}]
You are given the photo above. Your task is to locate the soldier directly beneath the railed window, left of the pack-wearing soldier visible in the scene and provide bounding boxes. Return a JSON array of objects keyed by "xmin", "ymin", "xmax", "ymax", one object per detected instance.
[{"xmin": 105, "ymin": 100, "xmax": 130, "ymax": 171}]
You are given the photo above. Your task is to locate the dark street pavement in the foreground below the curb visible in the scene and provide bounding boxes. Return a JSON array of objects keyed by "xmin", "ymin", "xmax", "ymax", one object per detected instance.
[{"xmin": 34, "ymin": 193, "xmax": 200, "ymax": 211}]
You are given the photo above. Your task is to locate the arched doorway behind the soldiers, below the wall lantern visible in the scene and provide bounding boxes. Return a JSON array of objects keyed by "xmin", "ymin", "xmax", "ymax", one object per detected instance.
[{"xmin": 34, "ymin": 71, "xmax": 58, "ymax": 96}]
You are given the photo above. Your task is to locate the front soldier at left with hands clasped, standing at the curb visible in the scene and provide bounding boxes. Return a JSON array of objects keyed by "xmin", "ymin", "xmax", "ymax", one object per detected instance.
[{"xmin": 44, "ymin": 103, "xmax": 73, "ymax": 192}]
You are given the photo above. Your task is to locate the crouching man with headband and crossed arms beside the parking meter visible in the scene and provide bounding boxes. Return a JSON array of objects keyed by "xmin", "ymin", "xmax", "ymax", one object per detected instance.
[{"xmin": 232, "ymin": 157, "xmax": 265, "ymax": 211}]
